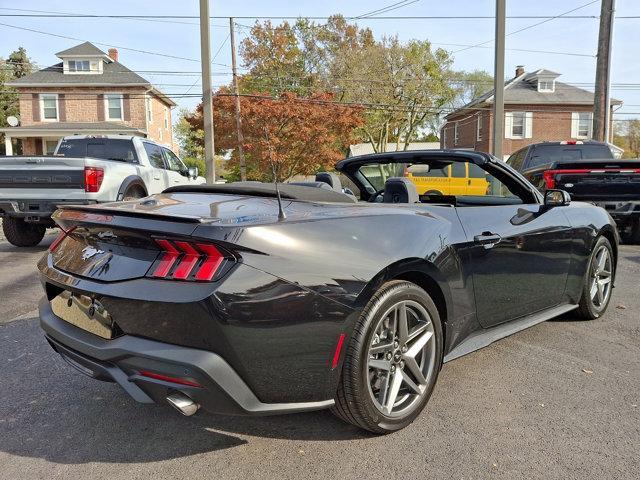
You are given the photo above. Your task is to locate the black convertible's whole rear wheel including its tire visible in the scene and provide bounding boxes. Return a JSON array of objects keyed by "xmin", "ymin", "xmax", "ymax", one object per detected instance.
[{"xmin": 332, "ymin": 280, "xmax": 443, "ymax": 434}]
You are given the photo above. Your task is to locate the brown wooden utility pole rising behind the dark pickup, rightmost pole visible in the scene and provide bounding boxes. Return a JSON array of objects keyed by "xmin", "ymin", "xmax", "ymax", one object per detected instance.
[{"xmin": 593, "ymin": 0, "xmax": 615, "ymax": 142}]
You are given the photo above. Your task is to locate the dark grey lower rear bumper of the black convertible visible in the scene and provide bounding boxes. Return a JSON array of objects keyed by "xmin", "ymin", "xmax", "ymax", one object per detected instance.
[{"xmin": 39, "ymin": 298, "xmax": 334, "ymax": 415}]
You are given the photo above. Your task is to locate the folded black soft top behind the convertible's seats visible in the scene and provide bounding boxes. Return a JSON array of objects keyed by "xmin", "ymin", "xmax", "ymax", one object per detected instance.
[{"xmin": 163, "ymin": 182, "xmax": 356, "ymax": 203}]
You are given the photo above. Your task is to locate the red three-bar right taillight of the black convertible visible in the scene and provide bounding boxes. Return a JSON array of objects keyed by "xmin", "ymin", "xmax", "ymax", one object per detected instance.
[{"xmin": 151, "ymin": 238, "xmax": 224, "ymax": 282}]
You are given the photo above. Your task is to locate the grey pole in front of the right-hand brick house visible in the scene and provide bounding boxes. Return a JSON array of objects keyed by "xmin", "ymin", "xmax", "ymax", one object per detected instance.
[{"xmin": 492, "ymin": 0, "xmax": 506, "ymax": 160}]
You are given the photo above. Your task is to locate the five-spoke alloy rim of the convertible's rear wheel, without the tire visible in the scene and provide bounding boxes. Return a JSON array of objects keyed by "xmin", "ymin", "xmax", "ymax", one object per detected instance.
[{"xmin": 367, "ymin": 300, "xmax": 436, "ymax": 417}]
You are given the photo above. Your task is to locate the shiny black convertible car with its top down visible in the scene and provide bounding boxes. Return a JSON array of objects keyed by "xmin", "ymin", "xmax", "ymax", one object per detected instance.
[{"xmin": 39, "ymin": 150, "xmax": 618, "ymax": 433}]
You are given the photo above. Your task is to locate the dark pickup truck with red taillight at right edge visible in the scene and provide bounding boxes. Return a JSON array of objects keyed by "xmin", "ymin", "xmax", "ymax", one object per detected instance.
[{"xmin": 507, "ymin": 141, "xmax": 640, "ymax": 243}]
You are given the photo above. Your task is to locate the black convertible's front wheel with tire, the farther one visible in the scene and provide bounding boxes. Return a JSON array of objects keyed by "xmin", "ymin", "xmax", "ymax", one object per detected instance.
[{"xmin": 577, "ymin": 237, "xmax": 615, "ymax": 320}]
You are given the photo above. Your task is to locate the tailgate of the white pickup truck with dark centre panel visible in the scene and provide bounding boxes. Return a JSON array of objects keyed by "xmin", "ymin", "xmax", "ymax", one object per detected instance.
[{"xmin": 0, "ymin": 156, "xmax": 86, "ymax": 200}]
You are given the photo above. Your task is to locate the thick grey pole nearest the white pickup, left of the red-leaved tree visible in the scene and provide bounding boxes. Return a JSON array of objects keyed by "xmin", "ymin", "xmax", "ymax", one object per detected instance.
[{"xmin": 200, "ymin": 0, "xmax": 216, "ymax": 183}]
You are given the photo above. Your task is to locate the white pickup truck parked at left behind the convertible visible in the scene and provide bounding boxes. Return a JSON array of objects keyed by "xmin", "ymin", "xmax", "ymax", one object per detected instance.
[{"xmin": 0, "ymin": 135, "xmax": 205, "ymax": 247}]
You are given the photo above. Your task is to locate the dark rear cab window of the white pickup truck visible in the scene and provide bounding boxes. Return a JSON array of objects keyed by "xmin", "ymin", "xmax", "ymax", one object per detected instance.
[{"xmin": 56, "ymin": 138, "xmax": 138, "ymax": 163}]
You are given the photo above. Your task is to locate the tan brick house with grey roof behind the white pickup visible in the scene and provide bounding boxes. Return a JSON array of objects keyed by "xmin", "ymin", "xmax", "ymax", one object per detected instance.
[{"xmin": 0, "ymin": 42, "xmax": 176, "ymax": 155}]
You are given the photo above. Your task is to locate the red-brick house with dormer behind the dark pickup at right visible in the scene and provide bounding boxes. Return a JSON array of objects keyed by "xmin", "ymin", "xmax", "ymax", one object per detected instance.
[{"xmin": 440, "ymin": 66, "xmax": 622, "ymax": 158}]
